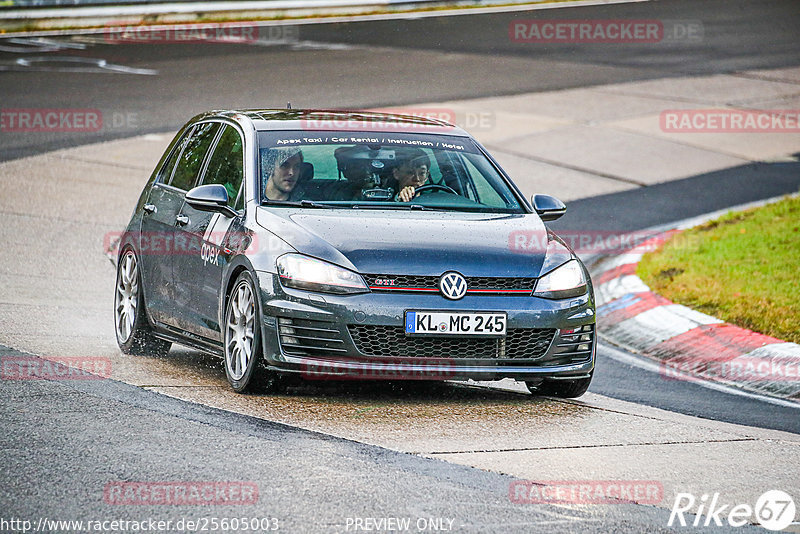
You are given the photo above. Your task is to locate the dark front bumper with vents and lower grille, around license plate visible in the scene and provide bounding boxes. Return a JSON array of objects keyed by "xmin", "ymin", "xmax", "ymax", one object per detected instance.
[{"xmin": 258, "ymin": 272, "xmax": 596, "ymax": 380}]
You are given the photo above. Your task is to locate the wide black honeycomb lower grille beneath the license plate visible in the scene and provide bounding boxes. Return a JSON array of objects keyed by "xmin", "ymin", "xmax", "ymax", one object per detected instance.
[{"xmin": 347, "ymin": 325, "xmax": 556, "ymax": 360}]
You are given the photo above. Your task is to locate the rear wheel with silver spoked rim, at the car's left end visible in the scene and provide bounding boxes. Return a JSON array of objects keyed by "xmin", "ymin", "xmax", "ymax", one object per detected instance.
[{"xmin": 114, "ymin": 248, "xmax": 172, "ymax": 356}]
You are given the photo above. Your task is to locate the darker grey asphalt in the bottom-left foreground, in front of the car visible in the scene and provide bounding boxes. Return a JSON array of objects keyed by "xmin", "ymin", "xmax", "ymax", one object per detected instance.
[{"xmin": 0, "ymin": 348, "xmax": 700, "ymax": 533}]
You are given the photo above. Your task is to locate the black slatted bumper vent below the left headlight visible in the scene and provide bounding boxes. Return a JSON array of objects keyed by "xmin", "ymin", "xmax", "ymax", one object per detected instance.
[{"xmin": 278, "ymin": 317, "xmax": 347, "ymax": 356}]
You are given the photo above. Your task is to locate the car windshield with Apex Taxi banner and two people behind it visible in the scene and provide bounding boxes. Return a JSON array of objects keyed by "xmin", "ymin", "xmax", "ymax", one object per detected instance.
[{"xmin": 259, "ymin": 131, "xmax": 524, "ymax": 213}]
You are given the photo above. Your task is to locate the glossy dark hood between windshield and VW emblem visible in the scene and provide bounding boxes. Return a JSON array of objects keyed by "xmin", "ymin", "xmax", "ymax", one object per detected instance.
[{"xmin": 257, "ymin": 207, "xmax": 552, "ymax": 277}]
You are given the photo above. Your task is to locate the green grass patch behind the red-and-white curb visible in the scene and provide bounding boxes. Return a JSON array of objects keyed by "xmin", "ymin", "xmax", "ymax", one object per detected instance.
[{"xmin": 636, "ymin": 197, "xmax": 800, "ymax": 343}]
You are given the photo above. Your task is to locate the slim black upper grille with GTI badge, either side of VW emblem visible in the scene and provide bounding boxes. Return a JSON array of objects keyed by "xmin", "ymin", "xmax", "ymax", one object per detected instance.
[{"xmin": 364, "ymin": 274, "xmax": 536, "ymax": 295}]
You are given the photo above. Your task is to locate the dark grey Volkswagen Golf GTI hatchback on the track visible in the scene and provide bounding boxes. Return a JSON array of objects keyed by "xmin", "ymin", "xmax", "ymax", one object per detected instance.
[{"xmin": 114, "ymin": 110, "xmax": 596, "ymax": 397}]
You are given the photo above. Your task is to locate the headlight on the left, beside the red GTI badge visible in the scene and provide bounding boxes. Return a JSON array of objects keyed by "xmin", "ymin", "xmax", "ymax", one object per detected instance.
[{"xmin": 277, "ymin": 254, "xmax": 369, "ymax": 294}]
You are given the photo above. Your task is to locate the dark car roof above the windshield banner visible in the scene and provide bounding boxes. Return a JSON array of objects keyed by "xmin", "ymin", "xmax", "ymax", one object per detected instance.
[{"xmin": 195, "ymin": 109, "xmax": 470, "ymax": 137}]
